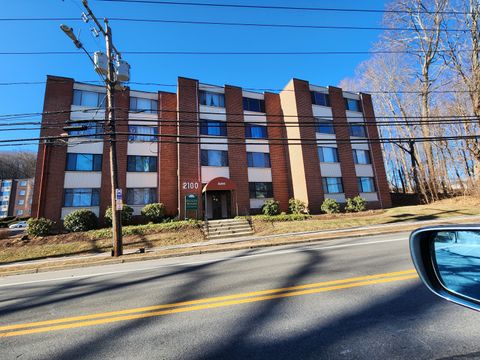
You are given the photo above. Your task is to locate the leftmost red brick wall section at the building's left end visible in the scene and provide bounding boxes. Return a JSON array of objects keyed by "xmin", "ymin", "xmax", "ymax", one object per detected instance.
[{"xmin": 32, "ymin": 75, "xmax": 74, "ymax": 224}]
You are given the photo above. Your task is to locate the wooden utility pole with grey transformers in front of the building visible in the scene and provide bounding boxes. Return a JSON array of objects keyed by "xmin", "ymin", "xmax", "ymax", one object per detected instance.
[{"xmin": 60, "ymin": 0, "xmax": 130, "ymax": 257}]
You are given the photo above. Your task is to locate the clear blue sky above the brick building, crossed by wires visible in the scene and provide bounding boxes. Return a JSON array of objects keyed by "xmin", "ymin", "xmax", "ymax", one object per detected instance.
[{"xmin": 0, "ymin": 0, "xmax": 384, "ymax": 151}]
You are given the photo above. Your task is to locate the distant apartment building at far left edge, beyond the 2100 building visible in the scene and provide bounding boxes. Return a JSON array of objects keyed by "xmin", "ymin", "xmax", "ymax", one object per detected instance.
[{"xmin": 0, "ymin": 179, "xmax": 34, "ymax": 219}]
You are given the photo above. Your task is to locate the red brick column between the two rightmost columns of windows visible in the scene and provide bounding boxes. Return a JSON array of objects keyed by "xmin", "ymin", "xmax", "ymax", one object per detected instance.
[{"xmin": 328, "ymin": 86, "xmax": 360, "ymax": 198}]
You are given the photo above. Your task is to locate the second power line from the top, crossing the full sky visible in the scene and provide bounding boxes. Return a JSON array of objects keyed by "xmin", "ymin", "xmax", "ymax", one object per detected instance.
[{"xmin": 0, "ymin": 17, "xmax": 470, "ymax": 32}]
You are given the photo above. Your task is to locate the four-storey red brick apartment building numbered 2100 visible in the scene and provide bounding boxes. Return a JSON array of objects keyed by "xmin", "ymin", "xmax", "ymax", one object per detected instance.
[{"xmin": 33, "ymin": 76, "xmax": 391, "ymax": 221}]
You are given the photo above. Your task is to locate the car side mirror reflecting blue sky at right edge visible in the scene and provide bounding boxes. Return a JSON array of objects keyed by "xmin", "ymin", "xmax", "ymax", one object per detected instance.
[{"xmin": 410, "ymin": 225, "xmax": 480, "ymax": 311}]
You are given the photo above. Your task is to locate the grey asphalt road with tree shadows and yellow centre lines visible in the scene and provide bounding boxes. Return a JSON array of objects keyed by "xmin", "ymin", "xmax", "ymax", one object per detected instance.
[{"xmin": 0, "ymin": 234, "xmax": 480, "ymax": 360}]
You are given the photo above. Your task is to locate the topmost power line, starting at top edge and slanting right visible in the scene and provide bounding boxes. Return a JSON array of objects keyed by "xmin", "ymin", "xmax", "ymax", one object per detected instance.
[{"xmin": 96, "ymin": 0, "xmax": 471, "ymax": 15}]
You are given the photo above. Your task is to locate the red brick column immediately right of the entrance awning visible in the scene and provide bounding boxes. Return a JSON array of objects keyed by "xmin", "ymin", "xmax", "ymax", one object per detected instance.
[{"xmin": 225, "ymin": 85, "xmax": 250, "ymax": 215}]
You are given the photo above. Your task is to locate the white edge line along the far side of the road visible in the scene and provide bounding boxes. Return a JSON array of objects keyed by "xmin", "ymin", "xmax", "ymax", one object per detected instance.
[{"xmin": 0, "ymin": 236, "xmax": 408, "ymax": 288}]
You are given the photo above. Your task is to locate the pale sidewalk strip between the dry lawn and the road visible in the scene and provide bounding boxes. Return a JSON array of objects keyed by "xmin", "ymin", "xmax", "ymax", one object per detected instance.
[{"xmin": 0, "ymin": 216, "xmax": 480, "ymax": 276}]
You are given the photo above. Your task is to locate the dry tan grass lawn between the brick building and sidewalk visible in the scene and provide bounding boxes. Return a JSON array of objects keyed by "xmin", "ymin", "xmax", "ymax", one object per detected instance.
[{"xmin": 0, "ymin": 197, "xmax": 480, "ymax": 264}]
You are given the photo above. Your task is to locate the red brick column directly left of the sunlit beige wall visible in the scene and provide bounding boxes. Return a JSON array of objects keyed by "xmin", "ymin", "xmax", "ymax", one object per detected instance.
[{"xmin": 265, "ymin": 93, "xmax": 292, "ymax": 212}]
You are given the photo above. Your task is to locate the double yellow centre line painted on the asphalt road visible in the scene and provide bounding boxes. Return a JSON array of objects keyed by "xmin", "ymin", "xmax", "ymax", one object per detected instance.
[{"xmin": 0, "ymin": 269, "xmax": 417, "ymax": 337}]
